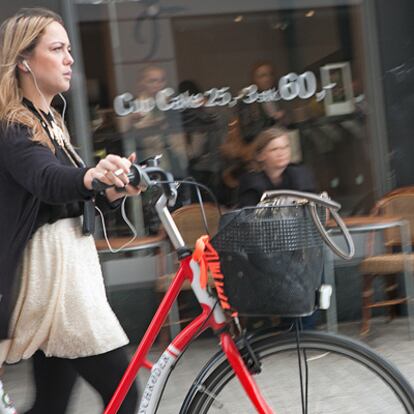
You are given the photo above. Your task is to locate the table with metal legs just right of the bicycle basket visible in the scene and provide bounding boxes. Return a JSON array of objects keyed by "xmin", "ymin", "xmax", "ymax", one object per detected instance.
[{"xmin": 324, "ymin": 216, "xmax": 414, "ymax": 339}]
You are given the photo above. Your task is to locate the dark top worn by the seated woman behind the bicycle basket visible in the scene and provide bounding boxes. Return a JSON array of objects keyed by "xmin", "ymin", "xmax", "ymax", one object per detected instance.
[{"xmin": 238, "ymin": 164, "xmax": 316, "ymax": 207}]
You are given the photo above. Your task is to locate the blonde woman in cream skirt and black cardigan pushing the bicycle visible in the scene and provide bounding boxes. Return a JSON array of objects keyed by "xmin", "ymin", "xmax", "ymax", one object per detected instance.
[{"xmin": 0, "ymin": 8, "xmax": 139, "ymax": 414}]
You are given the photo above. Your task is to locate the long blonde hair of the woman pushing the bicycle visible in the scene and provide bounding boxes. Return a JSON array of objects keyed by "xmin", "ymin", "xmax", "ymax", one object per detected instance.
[{"xmin": 0, "ymin": 8, "xmax": 65, "ymax": 150}]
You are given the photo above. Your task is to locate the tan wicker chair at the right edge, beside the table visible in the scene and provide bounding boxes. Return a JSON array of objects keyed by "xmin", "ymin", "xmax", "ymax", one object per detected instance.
[{"xmin": 359, "ymin": 186, "xmax": 414, "ymax": 335}]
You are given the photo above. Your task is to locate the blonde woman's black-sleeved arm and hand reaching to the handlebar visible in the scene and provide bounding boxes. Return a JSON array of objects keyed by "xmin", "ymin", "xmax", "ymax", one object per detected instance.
[{"xmin": 0, "ymin": 126, "xmax": 139, "ymax": 204}]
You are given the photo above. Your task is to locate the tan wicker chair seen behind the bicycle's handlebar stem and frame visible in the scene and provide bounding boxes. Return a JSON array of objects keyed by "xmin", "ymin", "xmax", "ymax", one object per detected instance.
[{"xmin": 155, "ymin": 203, "xmax": 220, "ymax": 336}]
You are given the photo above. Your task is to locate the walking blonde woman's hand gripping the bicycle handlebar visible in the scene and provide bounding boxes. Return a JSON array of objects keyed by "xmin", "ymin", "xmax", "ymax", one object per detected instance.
[{"xmin": 83, "ymin": 153, "xmax": 141, "ymax": 202}]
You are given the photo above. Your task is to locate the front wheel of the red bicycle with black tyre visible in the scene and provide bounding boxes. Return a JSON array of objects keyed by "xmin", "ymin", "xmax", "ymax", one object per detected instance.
[{"xmin": 181, "ymin": 332, "xmax": 414, "ymax": 414}]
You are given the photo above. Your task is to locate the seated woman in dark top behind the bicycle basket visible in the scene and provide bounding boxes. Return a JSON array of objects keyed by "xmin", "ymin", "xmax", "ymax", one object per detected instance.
[{"xmin": 238, "ymin": 127, "xmax": 316, "ymax": 207}]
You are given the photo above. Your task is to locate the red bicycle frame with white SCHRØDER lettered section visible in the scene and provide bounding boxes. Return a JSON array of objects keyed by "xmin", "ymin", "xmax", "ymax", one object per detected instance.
[{"xmin": 104, "ymin": 195, "xmax": 273, "ymax": 414}]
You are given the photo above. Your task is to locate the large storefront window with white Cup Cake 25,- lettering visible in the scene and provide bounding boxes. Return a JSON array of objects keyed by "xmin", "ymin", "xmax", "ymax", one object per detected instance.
[{"xmin": 77, "ymin": 1, "xmax": 374, "ymax": 232}]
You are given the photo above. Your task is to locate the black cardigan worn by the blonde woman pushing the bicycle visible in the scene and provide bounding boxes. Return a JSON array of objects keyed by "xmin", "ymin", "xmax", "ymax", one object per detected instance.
[{"xmin": 0, "ymin": 125, "xmax": 93, "ymax": 339}]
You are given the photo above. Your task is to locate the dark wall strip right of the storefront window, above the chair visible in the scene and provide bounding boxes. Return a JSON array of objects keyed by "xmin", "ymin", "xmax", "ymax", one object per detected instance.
[{"xmin": 377, "ymin": 0, "xmax": 414, "ymax": 186}]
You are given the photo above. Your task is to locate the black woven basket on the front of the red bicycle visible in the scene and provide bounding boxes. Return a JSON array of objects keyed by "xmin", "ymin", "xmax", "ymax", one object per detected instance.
[{"xmin": 211, "ymin": 192, "xmax": 351, "ymax": 316}]
